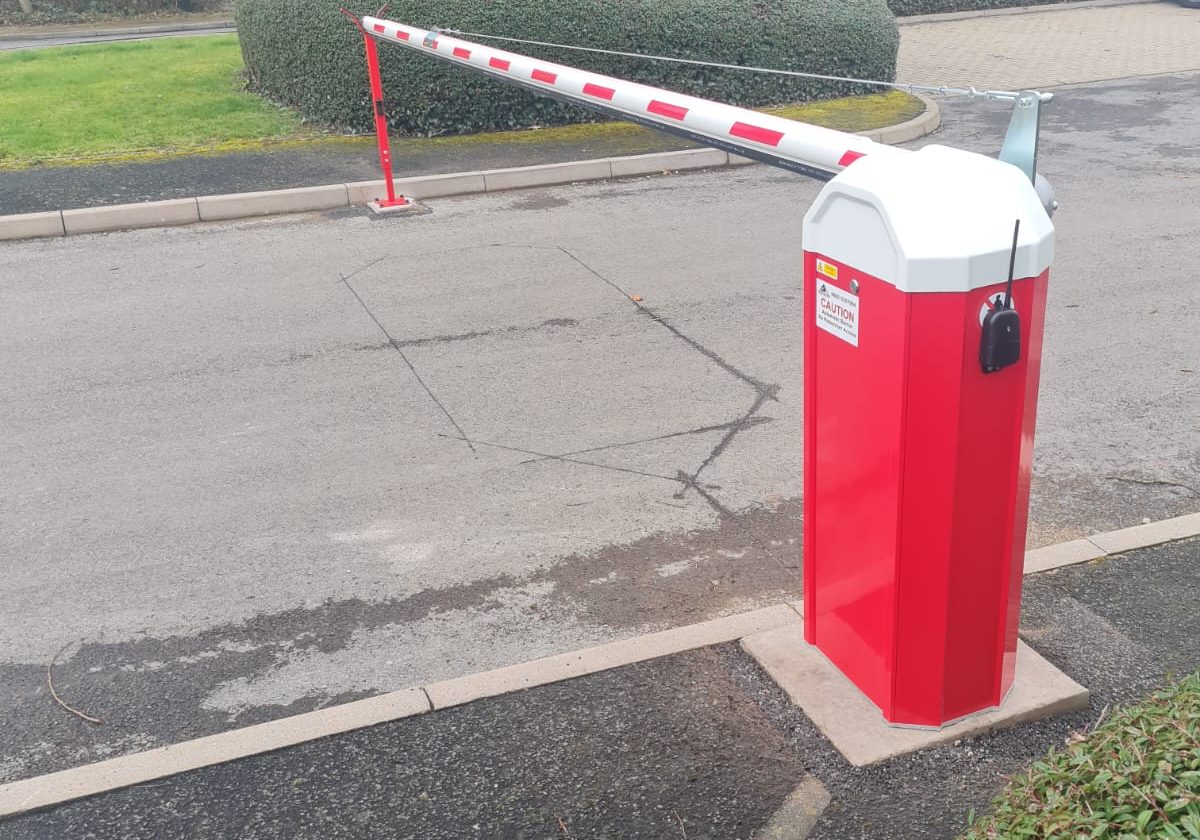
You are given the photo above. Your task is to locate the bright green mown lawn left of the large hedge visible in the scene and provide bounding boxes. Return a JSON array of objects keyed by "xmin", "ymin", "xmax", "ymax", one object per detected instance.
[{"xmin": 0, "ymin": 35, "xmax": 306, "ymax": 169}]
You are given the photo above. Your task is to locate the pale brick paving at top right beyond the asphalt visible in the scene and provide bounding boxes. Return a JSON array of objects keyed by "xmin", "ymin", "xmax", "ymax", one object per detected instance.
[{"xmin": 896, "ymin": 2, "xmax": 1200, "ymax": 88}]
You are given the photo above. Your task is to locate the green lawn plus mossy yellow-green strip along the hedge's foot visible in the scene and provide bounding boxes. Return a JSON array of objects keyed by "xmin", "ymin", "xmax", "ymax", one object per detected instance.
[{"xmin": 0, "ymin": 35, "xmax": 924, "ymax": 172}]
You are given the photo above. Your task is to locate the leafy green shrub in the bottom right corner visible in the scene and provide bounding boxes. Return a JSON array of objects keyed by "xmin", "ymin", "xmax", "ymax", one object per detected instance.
[{"xmin": 966, "ymin": 672, "xmax": 1200, "ymax": 840}]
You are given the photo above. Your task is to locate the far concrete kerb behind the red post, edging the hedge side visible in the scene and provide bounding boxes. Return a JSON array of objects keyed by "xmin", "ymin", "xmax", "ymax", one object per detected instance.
[{"xmin": 0, "ymin": 96, "xmax": 942, "ymax": 241}]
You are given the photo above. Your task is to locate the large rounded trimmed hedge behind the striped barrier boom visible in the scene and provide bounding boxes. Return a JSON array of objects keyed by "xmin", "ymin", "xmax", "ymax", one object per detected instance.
[{"xmin": 235, "ymin": 0, "xmax": 899, "ymax": 136}]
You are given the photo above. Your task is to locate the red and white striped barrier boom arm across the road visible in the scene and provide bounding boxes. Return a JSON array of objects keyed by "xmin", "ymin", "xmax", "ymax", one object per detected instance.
[{"xmin": 362, "ymin": 17, "xmax": 908, "ymax": 180}]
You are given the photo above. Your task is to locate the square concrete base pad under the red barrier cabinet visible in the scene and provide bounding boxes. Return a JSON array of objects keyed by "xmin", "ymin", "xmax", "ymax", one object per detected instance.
[{"xmin": 742, "ymin": 626, "xmax": 1088, "ymax": 767}]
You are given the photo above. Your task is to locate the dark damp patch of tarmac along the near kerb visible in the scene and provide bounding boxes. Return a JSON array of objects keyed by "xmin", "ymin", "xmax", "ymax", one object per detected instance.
[{"xmin": 0, "ymin": 499, "xmax": 800, "ymax": 782}]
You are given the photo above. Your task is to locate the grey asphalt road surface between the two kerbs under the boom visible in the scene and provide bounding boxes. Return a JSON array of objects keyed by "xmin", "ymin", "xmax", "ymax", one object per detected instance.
[{"xmin": 0, "ymin": 69, "xmax": 1200, "ymax": 780}]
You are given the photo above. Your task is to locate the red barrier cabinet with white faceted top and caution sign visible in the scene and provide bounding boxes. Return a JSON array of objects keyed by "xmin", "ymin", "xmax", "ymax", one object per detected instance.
[{"xmin": 804, "ymin": 146, "xmax": 1054, "ymax": 726}]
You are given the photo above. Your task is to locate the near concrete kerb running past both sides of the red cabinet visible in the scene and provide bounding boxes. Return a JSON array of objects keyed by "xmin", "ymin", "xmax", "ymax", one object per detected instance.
[{"xmin": 0, "ymin": 512, "xmax": 1200, "ymax": 818}]
